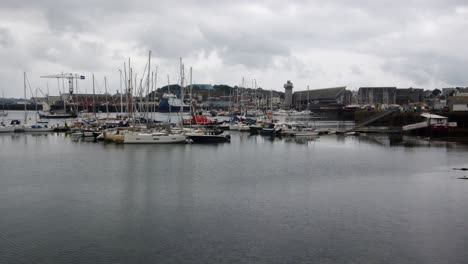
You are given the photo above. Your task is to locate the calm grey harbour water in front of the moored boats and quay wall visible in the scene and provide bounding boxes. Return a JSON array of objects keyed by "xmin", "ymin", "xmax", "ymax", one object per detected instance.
[{"xmin": 0, "ymin": 120, "xmax": 468, "ymax": 264}]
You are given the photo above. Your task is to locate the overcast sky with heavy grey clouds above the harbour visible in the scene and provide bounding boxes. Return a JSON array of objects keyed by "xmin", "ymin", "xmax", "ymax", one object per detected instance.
[{"xmin": 0, "ymin": 0, "xmax": 468, "ymax": 97}]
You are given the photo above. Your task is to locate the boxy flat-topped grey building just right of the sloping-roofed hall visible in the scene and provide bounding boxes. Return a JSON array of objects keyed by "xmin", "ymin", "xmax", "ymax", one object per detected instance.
[{"xmin": 358, "ymin": 87, "xmax": 397, "ymax": 105}]
